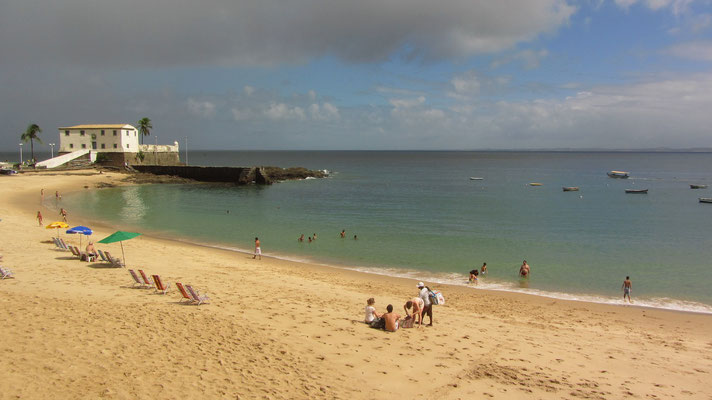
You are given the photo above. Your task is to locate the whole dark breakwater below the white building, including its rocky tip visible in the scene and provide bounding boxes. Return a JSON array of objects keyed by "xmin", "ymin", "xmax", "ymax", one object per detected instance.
[{"xmin": 133, "ymin": 165, "xmax": 327, "ymax": 185}]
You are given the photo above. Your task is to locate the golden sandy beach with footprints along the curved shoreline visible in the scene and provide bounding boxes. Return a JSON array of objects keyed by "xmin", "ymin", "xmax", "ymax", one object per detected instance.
[{"xmin": 0, "ymin": 170, "xmax": 712, "ymax": 399}]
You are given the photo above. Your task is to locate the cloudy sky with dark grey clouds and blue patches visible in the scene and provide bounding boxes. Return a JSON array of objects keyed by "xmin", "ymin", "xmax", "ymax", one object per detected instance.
[{"xmin": 0, "ymin": 0, "xmax": 712, "ymax": 151}]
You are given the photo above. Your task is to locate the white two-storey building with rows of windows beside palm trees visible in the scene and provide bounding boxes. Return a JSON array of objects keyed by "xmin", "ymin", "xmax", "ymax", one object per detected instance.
[{"xmin": 59, "ymin": 124, "xmax": 139, "ymax": 154}]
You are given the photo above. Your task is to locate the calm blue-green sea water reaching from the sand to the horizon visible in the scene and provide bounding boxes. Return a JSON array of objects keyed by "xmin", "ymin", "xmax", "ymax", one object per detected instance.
[{"xmin": 64, "ymin": 152, "xmax": 712, "ymax": 312}]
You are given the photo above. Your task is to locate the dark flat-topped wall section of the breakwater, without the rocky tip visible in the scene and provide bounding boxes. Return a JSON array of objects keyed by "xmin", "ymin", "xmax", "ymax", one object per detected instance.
[{"xmin": 131, "ymin": 165, "xmax": 272, "ymax": 185}]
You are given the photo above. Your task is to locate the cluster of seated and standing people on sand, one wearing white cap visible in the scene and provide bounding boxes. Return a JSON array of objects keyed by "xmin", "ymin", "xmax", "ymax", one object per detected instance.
[{"xmin": 364, "ymin": 282, "xmax": 433, "ymax": 332}]
